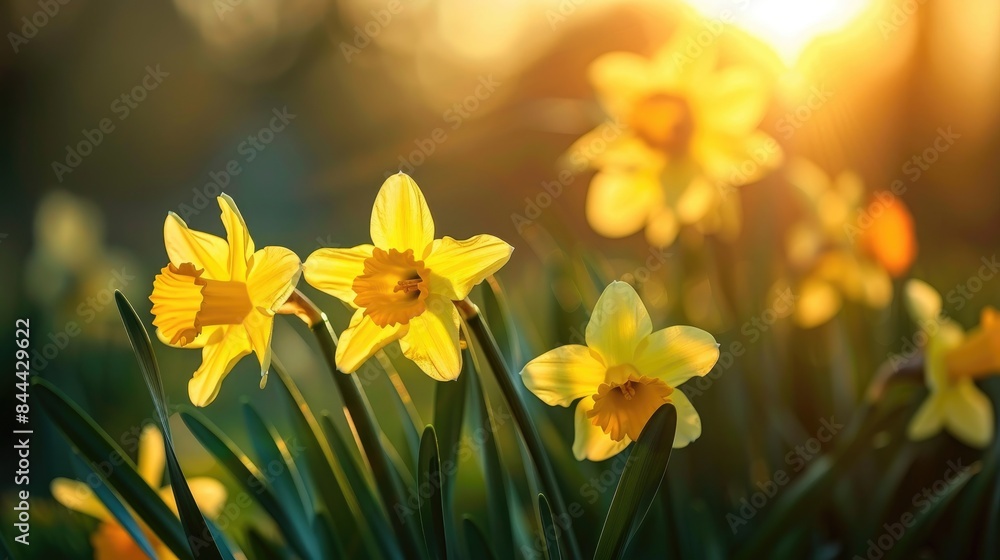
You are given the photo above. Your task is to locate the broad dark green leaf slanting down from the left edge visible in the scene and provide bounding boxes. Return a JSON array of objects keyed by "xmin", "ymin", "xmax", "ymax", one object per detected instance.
[{"xmin": 32, "ymin": 376, "xmax": 192, "ymax": 558}]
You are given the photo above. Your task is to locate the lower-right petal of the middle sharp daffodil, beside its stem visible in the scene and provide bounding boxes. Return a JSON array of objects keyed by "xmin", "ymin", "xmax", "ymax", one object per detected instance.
[{"xmin": 399, "ymin": 295, "xmax": 462, "ymax": 381}]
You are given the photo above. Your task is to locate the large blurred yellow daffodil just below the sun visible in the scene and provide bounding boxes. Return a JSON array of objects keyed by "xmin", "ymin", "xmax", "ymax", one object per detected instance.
[{"xmin": 568, "ymin": 21, "xmax": 782, "ymax": 246}]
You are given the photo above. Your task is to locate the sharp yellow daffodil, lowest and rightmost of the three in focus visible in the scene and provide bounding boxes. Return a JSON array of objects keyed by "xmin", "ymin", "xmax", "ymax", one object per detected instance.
[{"xmin": 521, "ymin": 281, "xmax": 719, "ymax": 461}]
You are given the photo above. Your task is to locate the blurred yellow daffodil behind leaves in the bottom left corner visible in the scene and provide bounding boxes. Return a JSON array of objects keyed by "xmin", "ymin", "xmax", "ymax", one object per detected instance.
[{"xmin": 52, "ymin": 426, "xmax": 226, "ymax": 560}]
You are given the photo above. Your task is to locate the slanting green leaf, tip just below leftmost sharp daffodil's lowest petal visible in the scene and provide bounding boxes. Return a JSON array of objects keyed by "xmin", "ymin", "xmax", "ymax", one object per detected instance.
[{"xmin": 181, "ymin": 407, "xmax": 319, "ymax": 558}]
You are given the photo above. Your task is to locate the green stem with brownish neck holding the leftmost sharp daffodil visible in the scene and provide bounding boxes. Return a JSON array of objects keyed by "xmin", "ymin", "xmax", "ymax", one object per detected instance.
[{"xmin": 292, "ymin": 290, "xmax": 423, "ymax": 558}]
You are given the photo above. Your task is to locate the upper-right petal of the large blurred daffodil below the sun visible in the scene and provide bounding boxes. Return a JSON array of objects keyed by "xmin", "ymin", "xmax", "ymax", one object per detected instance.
[{"xmin": 692, "ymin": 66, "xmax": 770, "ymax": 133}]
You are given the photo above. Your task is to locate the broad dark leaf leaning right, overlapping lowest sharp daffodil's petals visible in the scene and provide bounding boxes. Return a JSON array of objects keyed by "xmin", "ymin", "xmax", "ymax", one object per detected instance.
[{"xmin": 594, "ymin": 403, "xmax": 677, "ymax": 560}]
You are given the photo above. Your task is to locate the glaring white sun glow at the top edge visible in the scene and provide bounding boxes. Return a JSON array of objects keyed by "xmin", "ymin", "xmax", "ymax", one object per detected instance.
[{"xmin": 687, "ymin": 0, "xmax": 872, "ymax": 65}]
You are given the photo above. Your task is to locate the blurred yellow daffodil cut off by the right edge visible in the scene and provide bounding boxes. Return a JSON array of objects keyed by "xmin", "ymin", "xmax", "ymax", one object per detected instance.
[{"xmin": 906, "ymin": 280, "xmax": 1000, "ymax": 448}]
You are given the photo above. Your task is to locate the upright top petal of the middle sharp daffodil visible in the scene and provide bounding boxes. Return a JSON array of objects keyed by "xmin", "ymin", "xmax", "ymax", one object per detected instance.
[{"xmin": 371, "ymin": 171, "xmax": 434, "ymax": 255}]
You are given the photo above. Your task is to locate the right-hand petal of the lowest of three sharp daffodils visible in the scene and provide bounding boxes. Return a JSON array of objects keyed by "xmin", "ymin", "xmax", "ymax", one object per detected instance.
[{"xmin": 634, "ymin": 326, "xmax": 719, "ymax": 387}]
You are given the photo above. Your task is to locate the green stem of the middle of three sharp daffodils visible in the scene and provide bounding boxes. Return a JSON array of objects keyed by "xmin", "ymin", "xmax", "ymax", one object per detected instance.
[{"xmin": 455, "ymin": 298, "xmax": 583, "ymax": 558}]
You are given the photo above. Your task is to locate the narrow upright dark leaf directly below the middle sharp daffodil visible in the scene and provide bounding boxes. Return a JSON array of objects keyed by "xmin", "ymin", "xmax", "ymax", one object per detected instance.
[{"xmin": 417, "ymin": 425, "xmax": 448, "ymax": 558}]
